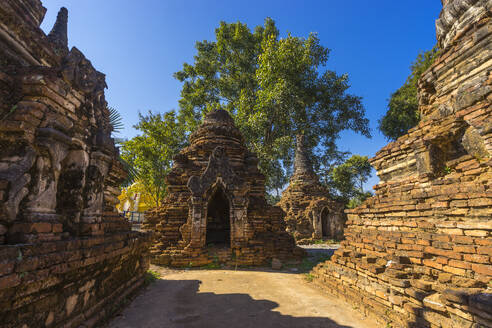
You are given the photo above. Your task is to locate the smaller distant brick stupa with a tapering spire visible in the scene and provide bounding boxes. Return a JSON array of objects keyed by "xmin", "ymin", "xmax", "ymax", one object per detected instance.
[{"xmin": 278, "ymin": 135, "xmax": 345, "ymax": 244}]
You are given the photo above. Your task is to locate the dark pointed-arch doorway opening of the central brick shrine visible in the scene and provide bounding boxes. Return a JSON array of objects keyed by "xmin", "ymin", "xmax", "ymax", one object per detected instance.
[{"xmin": 206, "ymin": 188, "xmax": 231, "ymax": 246}]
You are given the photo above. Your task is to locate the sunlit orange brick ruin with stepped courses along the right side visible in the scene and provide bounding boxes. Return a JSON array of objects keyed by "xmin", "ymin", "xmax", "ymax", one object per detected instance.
[{"xmin": 313, "ymin": 0, "xmax": 492, "ymax": 327}]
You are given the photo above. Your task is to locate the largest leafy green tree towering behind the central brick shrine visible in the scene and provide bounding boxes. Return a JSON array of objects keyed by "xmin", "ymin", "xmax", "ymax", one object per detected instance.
[{"xmin": 175, "ymin": 18, "xmax": 370, "ymax": 191}]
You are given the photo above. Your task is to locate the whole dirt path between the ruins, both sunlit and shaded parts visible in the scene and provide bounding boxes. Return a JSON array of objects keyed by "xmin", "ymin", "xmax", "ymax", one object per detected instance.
[{"xmin": 109, "ymin": 267, "xmax": 378, "ymax": 328}]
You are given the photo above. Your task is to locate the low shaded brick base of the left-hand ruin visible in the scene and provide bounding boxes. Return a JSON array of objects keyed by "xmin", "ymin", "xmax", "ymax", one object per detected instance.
[{"xmin": 0, "ymin": 232, "xmax": 150, "ymax": 328}]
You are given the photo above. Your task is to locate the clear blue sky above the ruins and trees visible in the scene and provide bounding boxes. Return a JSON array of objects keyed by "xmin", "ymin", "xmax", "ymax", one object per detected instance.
[{"xmin": 42, "ymin": 0, "xmax": 441, "ymax": 188}]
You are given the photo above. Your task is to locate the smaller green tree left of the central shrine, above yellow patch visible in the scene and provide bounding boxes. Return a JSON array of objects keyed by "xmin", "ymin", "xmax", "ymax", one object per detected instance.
[{"xmin": 121, "ymin": 111, "xmax": 187, "ymax": 206}]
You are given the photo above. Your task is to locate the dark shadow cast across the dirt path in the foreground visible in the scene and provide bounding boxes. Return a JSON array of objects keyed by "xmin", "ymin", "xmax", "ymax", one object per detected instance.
[{"xmin": 109, "ymin": 279, "xmax": 358, "ymax": 328}]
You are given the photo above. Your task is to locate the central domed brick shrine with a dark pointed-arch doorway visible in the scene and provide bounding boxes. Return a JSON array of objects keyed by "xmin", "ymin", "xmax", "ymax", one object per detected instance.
[{"xmin": 144, "ymin": 110, "xmax": 302, "ymax": 266}]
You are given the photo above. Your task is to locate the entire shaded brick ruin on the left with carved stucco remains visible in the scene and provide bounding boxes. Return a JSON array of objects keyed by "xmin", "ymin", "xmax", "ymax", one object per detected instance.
[{"xmin": 0, "ymin": 0, "xmax": 150, "ymax": 327}]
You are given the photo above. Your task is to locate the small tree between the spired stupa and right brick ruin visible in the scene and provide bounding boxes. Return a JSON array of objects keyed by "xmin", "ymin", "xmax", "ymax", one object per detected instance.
[{"xmin": 330, "ymin": 155, "xmax": 372, "ymax": 208}]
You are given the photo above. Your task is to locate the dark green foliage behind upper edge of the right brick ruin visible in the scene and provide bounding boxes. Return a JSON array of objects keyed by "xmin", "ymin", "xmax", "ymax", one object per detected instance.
[{"xmin": 379, "ymin": 47, "xmax": 438, "ymax": 140}]
